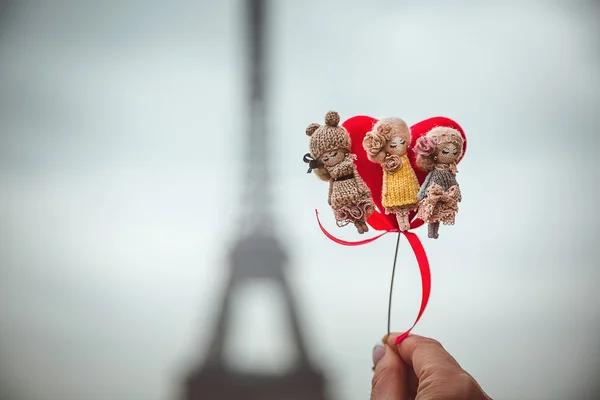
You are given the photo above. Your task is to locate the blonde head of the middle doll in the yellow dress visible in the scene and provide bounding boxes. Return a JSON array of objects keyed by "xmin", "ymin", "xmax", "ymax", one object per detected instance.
[{"xmin": 363, "ymin": 118, "xmax": 410, "ymax": 163}]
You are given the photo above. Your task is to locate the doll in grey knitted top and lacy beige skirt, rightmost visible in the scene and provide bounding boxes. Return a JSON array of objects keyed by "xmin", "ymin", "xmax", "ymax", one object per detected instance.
[{"xmin": 414, "ymin": 127, "xmax": 464, "ymax": 239}]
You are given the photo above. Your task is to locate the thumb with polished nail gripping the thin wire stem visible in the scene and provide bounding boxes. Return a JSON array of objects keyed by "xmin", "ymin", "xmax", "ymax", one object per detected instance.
[{"xmin": 371, "ymin": 345, "xmax": 407, "ymax": 400}]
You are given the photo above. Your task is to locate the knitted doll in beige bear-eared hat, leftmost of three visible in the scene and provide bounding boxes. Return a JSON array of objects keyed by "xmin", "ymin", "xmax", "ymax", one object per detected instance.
[{"xmin": 304, "ymin": 111, "xmax": 375, "ymax": 234}]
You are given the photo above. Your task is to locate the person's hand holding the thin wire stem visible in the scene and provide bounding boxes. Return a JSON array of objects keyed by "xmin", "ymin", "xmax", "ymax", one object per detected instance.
[{"xmin": 371, "ymin": 334, "xmax": 492, "ymax": 400}]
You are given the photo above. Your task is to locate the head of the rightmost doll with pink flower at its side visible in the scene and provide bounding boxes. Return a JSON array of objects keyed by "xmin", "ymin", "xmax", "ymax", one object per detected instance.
[{"xmin": 414, "ymin": 126, "xmax": 464, "ymax": 172}]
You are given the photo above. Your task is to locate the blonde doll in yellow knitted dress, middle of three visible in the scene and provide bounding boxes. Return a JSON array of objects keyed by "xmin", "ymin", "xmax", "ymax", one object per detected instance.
[{"xmin": 363, "ymin": 118, "xmax": 419, "ymax": 231}]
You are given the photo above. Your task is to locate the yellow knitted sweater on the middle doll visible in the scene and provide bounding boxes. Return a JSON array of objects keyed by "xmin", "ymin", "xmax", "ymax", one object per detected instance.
[{"xmin": 381, "ymin": 154, "xmax": 420, "ymax": 208}]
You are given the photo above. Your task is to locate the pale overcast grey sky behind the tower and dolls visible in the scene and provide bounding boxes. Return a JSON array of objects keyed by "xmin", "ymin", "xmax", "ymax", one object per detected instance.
[{"xmin": 0, "ymin": 0, "xmax": 600, "ymax": 400}]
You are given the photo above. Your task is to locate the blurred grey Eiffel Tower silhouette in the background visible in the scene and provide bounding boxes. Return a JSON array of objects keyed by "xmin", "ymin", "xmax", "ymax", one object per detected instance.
[{"xmin": 184, "ymin": 0, "xmax": 325, "ymax": 400}]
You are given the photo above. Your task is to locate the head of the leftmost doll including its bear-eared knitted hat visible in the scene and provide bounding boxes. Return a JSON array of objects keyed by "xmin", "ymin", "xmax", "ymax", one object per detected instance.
[{"xmin": 306, "ymin": 111, "xmax": 350, "ymax": 180}]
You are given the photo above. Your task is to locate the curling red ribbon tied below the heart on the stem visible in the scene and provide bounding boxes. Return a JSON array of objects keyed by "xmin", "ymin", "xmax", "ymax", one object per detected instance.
[{"xmin": 315, "ymin": 210, "xmax": 431, "ymax": 344}]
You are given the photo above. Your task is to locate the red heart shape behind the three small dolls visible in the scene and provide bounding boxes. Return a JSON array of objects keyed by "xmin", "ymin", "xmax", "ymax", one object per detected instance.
[{"xmin": 342, "ymin": 115, "xmax": 467, "ymax": 231}]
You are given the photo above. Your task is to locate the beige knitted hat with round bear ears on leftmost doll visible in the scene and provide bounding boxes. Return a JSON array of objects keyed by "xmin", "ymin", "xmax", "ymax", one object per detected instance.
[{"xmin": 306, "ymin": 111, "xmax": 350, "ymax": 158}]
